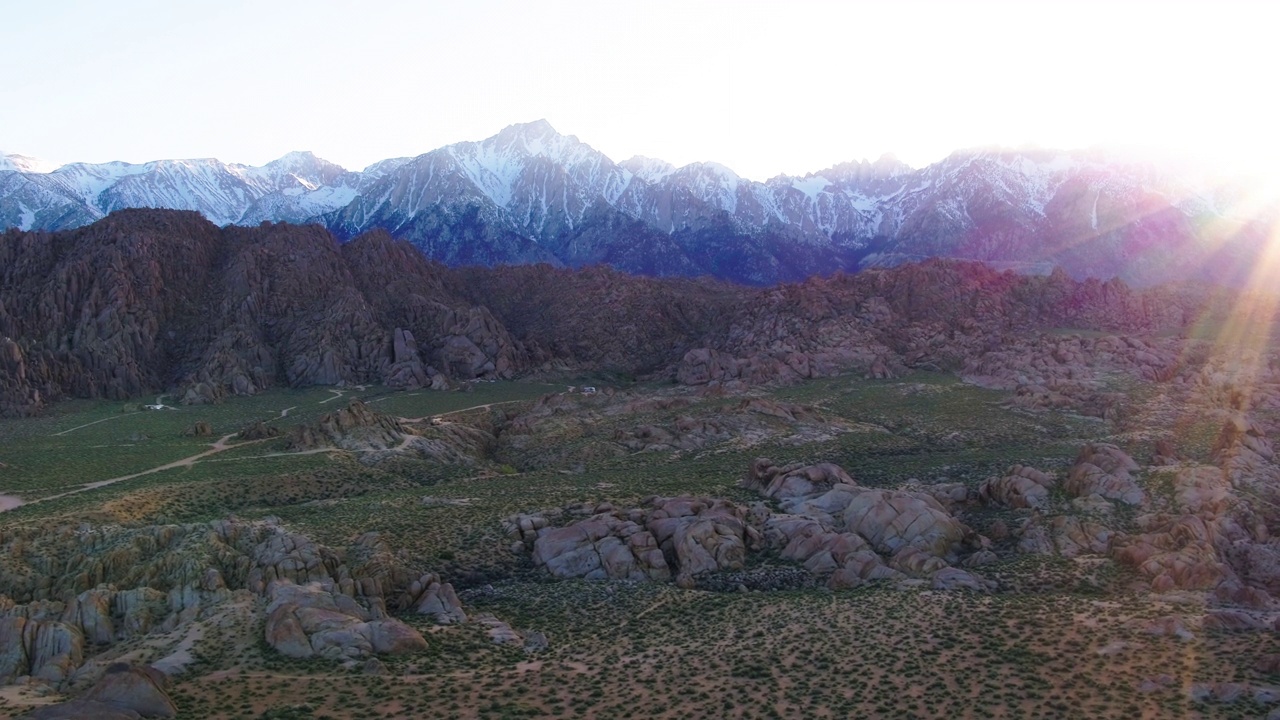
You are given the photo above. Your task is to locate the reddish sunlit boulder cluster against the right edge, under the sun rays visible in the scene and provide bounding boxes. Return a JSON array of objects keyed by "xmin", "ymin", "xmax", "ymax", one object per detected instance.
[{"xmin": 977, "ymin": 414, "xmax": 1280, "ymax": 614}]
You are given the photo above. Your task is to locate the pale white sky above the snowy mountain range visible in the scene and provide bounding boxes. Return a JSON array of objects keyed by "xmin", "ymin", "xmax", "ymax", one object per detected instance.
[{"xmin": 0, "ymin": 0, "xmax": 1280, "ymax": 179}]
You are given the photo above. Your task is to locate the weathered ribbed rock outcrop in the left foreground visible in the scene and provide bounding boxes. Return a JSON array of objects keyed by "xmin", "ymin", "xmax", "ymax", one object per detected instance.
[{"xmin": 0, "ymin": 519, "xmax": 467, "ymax": 687}]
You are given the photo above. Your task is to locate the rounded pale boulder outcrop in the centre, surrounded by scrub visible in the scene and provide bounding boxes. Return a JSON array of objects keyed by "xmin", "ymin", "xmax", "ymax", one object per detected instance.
[{"xmin": 504, "ymin": 459, "xmax": 995, "ymax": 591}]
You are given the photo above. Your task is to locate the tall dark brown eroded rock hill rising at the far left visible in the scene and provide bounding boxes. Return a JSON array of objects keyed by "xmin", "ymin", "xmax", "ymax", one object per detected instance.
[{"xmin": 0, "ymin": 210, "xmax": 527, "ymax": 415}]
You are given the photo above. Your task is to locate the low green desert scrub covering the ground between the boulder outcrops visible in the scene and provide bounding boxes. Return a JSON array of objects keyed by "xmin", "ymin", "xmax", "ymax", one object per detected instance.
[{"xmin": 0, "ymin": 373, "xmax": 1280, "ymax": 719}]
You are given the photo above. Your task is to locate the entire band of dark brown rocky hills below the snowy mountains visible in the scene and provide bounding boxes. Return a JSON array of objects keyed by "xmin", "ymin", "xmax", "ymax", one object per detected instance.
[{"xmin": 0, "ymin": 210, "xmax": 1249, "ymax": 415}]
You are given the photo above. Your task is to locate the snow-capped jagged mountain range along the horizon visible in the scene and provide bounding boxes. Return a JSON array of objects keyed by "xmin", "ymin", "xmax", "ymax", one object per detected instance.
[{"xmin": 0, "ymin": 120, "xmax": 1280, "ymax": 283}]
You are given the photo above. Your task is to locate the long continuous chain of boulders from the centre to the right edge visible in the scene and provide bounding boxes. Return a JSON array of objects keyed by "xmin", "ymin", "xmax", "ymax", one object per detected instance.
[{"xmin": 504, "ymin": 415, "xmax": 1280, "ymax": 609}]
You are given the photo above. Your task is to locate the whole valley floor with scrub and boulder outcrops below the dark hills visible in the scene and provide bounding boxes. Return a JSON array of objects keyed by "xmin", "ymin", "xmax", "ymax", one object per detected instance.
[{"xmin": 0, "ymin": 345, "xmax": 1280, "ymax": 717}]
